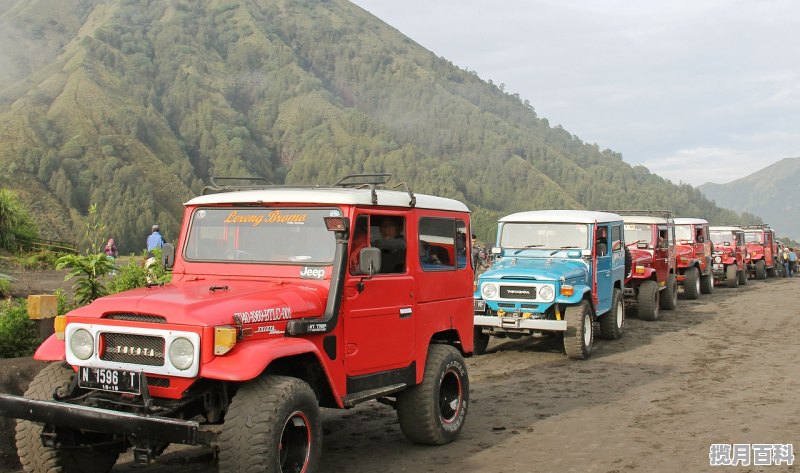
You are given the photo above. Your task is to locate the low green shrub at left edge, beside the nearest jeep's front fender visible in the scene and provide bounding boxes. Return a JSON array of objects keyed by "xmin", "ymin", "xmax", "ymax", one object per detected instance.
[{"xmin": 0, "ymin": 299, "xmax": 40, "ymax": 358}]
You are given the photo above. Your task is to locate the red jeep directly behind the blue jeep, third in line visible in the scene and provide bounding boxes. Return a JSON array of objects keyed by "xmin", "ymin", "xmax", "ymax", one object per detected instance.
[{"xmin": 612, "ymin": 210, "xmax": 678, "ymax": 320}]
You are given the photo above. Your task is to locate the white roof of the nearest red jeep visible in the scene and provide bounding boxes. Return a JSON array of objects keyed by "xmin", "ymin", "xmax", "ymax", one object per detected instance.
[{"xmin": 183, "ymin": 187, "xmax": 469, "ymax": 212}]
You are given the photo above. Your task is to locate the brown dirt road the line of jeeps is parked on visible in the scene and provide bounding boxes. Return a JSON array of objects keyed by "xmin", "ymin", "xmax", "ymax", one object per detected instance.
[{"xmin": 1, "ymin": 279, "xmax": 800, "ymax": 473}]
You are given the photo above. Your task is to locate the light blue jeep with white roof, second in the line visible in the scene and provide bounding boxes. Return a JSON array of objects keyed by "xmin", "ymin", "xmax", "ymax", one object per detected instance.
[{"xmin": 474, "ymin": 210, "xmax": 626, "ymax": 359}]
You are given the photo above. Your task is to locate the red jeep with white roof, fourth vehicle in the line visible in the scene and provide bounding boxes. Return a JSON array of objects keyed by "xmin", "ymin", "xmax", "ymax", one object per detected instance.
[{"xmin": 675, "ymin": 218, "xmax": 714, "ymax": 299}]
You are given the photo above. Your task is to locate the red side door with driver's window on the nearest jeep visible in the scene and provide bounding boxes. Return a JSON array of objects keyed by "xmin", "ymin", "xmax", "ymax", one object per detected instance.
[{"xmin": 341, "ymin": 212, "xmax": 416, "ymax": 380}]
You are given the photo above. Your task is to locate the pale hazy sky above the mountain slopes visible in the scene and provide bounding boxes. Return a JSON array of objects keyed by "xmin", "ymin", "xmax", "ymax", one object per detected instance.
[{"xmin": 353, "ymin": 0, "xmax": 800, "ymax": 185}]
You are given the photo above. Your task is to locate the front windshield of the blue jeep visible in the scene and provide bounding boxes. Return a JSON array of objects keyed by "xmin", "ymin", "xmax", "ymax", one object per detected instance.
[{"xmin": 500, "ymin": 222, "xmax": 589, "ymax": 250}]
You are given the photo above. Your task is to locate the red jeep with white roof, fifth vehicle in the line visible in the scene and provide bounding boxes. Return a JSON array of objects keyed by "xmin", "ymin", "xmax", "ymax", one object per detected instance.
[{"xmin": 709, "ymin": 226, "xmax": 747, "ymax": 287}]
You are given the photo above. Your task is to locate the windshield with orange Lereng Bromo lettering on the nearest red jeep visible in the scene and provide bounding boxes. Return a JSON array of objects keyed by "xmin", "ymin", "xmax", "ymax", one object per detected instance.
[{"xmin": 183, "ymin": 207, "xmax": 341, "ymax": 264}]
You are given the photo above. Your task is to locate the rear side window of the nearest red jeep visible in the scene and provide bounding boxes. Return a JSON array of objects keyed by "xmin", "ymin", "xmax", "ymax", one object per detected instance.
[{"xmin": 419, "ymin": 217, "xmax": 456, "ymax": 271}]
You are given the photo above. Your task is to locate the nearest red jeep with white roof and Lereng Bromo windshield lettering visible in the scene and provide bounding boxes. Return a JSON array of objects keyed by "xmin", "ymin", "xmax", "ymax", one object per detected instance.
[{"xmin": 0, "ymin": 174, "xmax": 473, "ymax": 472}]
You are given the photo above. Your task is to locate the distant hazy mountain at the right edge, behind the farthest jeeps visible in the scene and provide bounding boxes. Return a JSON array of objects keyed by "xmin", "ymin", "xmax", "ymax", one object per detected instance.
[{"xmin": 699, "ymin": 158, "xmax": 800, "ymax": 241}]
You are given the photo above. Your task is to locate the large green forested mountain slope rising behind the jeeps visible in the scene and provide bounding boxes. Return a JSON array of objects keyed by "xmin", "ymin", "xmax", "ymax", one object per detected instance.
[{"xmin": 0, "ymin": 0, "xmax": 750, "ymax": 253}]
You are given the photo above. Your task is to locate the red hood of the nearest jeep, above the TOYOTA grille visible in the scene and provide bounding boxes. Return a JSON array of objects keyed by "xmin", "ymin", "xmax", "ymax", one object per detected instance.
[{"xmin": 69, "ymin": 279, "xmax": 328, "ymax": 326}]
